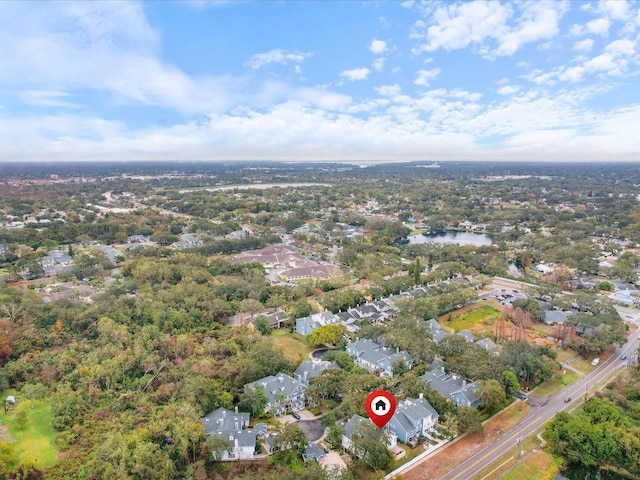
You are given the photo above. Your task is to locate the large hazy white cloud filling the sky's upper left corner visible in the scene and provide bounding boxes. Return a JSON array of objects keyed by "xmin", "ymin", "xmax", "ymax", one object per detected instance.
[{"xmin": 0, "ymin": 2, "xmax": 236, "ymax": 112}]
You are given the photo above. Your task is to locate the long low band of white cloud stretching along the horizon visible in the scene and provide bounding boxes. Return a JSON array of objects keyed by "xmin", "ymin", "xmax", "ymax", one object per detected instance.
[{"xmin": 5, "ymin": 86, "xmax": 640, "ymax": 161}]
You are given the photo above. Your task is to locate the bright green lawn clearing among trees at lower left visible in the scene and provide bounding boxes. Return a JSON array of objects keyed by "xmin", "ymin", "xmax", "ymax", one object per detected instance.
[{"xmin": 0, "ymin": 391, "xmax": 58, "ymax": 467}]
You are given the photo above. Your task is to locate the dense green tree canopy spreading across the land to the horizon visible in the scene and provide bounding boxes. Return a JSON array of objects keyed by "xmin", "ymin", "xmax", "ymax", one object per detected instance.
[{"xmin": 0, "ymin": 162, "xmax": 640, "ymax": 479}]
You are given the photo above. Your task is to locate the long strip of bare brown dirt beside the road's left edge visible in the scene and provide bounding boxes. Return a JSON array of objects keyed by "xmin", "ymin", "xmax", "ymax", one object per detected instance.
[{"xmin": 402, "ymin": 402, "xmax": 529, "ymax": 480}]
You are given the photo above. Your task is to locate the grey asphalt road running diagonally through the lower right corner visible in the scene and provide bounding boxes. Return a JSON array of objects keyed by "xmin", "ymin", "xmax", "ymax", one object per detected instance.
[{"xmin": 442, "ymin": 309, "xmax": 640, "ymax": 480}]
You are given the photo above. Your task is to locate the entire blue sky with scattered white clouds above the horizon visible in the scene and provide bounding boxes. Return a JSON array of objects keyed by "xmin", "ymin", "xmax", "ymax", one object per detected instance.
[{"xmin": 0, "ymin": 0, "xmax": 640, "ymax": 162}]
